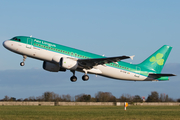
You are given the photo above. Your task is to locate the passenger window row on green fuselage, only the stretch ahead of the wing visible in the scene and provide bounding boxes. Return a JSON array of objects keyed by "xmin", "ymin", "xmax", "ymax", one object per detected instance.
[{"xmin": 34, "ymin": 43, "xmax": 89, "ymax": 59}]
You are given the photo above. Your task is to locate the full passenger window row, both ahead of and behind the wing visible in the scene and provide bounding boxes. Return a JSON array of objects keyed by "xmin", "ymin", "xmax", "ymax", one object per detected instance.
[{"xmin": 34, "ymin": 43, "xmax": 130, "ymax": 70}]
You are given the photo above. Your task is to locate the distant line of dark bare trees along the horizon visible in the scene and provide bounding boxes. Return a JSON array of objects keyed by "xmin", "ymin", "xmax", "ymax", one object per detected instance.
[{"xmin": 0, "ymin": 91, "xmax": 180, "ymax": 103}]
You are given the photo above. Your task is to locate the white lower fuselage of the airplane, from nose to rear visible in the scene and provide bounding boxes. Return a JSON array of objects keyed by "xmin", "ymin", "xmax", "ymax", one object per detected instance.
[{"xmin": 3, "ymin": 40, "xmax": 155, "ymax": 81}]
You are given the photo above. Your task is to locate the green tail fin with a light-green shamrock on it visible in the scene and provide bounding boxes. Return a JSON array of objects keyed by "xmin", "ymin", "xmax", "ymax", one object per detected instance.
[{"xmin": 139, "ymin": 45, "xmax": 172, "ymax": 73}]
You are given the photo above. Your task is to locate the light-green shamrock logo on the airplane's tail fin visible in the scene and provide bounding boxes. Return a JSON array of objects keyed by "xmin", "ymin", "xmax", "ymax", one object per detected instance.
[{"xmin": 150, "ymin": 53, "xmax": 164, "ymax": 65}]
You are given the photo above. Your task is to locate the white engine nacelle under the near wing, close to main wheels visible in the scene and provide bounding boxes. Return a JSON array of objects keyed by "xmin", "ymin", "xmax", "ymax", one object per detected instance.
[{"xmin": 60, "ymin": 57, "xmax": 78, "ymax": 70}]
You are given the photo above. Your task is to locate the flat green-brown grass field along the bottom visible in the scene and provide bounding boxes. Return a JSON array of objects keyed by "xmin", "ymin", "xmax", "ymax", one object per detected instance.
[{"xmin": 0, "ymin": 106, "xmax": 180, "ymax": 120}]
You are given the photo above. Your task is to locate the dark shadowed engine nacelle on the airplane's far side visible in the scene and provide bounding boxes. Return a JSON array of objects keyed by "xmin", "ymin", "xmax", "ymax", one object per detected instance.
[{"xmin": 43, "ymin": 61, "xmax": 66, "ymax": 72}]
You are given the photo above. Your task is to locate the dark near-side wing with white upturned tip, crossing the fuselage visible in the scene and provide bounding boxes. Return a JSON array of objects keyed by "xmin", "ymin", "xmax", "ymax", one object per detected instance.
[{"xmin": 78, "ymin": 56, "xmax": 134, "ymax": 69}]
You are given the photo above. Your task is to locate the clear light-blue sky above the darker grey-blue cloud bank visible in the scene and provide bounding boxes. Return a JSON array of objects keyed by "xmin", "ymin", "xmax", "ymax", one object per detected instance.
[{"xmin": 0, "ymin": 0, "xmax": 180, "ymax": 99}]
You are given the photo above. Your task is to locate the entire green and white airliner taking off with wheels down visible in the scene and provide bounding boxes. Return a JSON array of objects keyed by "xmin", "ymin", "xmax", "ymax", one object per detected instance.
[{"xmin": 3, "ymin": 36, "xmax": 175, "ymax": 82}]
